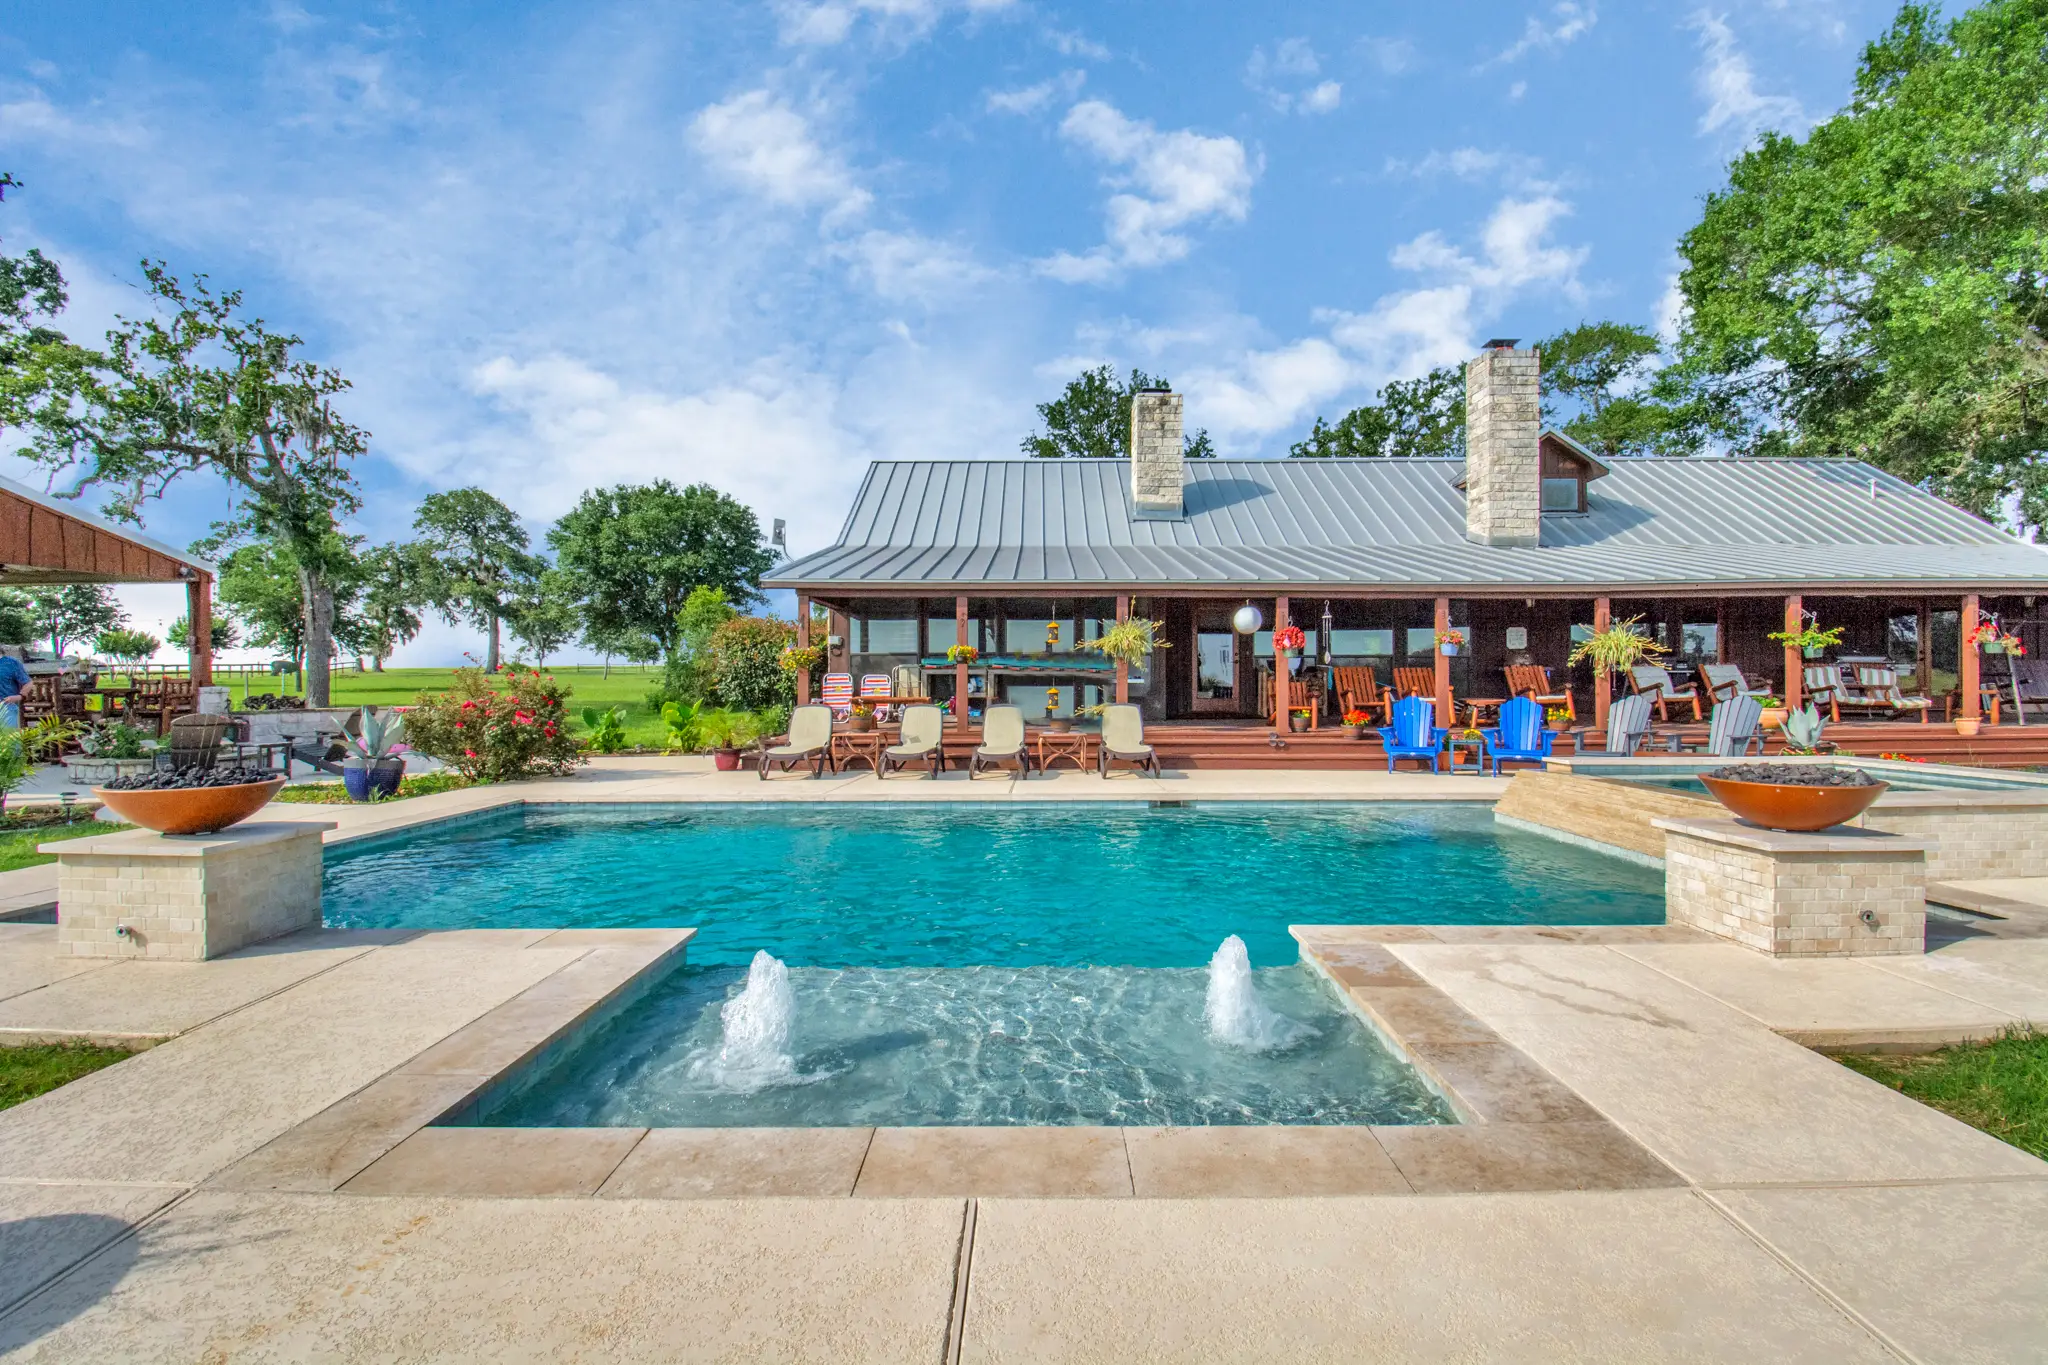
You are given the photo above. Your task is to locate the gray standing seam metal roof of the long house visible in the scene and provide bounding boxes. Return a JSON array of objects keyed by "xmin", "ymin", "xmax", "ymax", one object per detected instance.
[{"xmin": 766, "ymin": 458, "xmax": 2048, "ymax": 593}]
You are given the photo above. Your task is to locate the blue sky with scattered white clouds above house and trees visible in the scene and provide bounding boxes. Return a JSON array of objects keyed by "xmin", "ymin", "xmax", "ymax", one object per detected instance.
[{"xmin": 0, "ymin": 0, "xmax": 1892, "ymax": 663}]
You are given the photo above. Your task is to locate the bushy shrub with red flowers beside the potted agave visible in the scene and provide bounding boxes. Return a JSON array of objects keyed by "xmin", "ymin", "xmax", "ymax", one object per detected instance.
[{"xmin": 406, "ymin": 663, "xmax": 584, "ymax": 782}]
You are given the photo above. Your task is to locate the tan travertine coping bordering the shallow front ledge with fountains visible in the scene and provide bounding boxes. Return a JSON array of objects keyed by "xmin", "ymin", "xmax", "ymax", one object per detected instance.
[{"xmin": 211, "ymin": 925, "xmax": 1702, "ymax": 1199}]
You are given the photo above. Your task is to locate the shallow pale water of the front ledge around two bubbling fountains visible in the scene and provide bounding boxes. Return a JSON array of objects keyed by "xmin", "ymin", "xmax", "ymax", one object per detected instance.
[{"xmin": 479, "ymin": 964, "xmax": 1452, "ymax": 1128}]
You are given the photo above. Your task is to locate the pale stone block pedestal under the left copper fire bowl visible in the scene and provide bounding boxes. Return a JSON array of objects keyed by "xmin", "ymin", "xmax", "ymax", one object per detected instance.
[{"xmin": 54, "ymin": 821, "xmax": 334, "ymax": 962}]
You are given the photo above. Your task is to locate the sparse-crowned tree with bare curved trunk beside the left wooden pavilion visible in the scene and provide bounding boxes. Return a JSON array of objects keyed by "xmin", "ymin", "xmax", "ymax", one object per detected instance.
[{"xmin": 20, "ymin": 262, "xmax": 369, "ymax": 706}]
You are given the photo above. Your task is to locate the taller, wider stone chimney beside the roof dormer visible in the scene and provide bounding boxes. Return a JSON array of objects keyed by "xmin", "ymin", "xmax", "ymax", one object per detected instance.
[{"xmin": 1464, "ymin": 340, "xmax": 1542, "ymax": 544}]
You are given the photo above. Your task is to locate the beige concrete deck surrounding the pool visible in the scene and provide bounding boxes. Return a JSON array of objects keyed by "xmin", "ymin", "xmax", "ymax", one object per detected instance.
[{"xmin": 0, "ymin": 761, "xmax": 2048, "ymax": 1361}]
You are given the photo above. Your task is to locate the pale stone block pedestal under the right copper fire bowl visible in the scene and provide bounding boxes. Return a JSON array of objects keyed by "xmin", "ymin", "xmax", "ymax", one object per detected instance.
[{"xmin": 1657, "ymin": 819, "xmax": 1927, "ymax": 958}]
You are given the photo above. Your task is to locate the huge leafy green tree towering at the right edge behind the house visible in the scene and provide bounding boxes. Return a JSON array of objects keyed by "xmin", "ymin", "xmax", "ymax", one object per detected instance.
[{"xmin": 1679, "ymin": 0, "xmax": 2048, "ymax": 526}]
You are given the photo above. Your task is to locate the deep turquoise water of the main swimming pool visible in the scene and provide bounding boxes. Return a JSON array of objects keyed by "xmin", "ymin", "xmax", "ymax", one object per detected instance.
[{"xmin": 326, "ymin": 802, "xmax": 1665, "ymax": 968}]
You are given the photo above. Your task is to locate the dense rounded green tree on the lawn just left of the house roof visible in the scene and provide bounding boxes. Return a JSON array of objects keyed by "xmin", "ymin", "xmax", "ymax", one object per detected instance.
[{"xmin": 547, "ymin": 479, "xmax": 776, "ymax": 659}]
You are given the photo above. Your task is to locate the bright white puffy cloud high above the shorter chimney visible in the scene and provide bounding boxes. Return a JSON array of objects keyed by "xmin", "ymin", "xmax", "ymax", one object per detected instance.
[{"xmin": 1040, "ymin": 100, "xmax": 1257, "ymax": 282}]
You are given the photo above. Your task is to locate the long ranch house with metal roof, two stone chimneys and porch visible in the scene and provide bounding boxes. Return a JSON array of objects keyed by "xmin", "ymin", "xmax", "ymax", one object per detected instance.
[{"xmin": 768, "ymin": 344, "xmax": 2048, "ymax": 749}]
